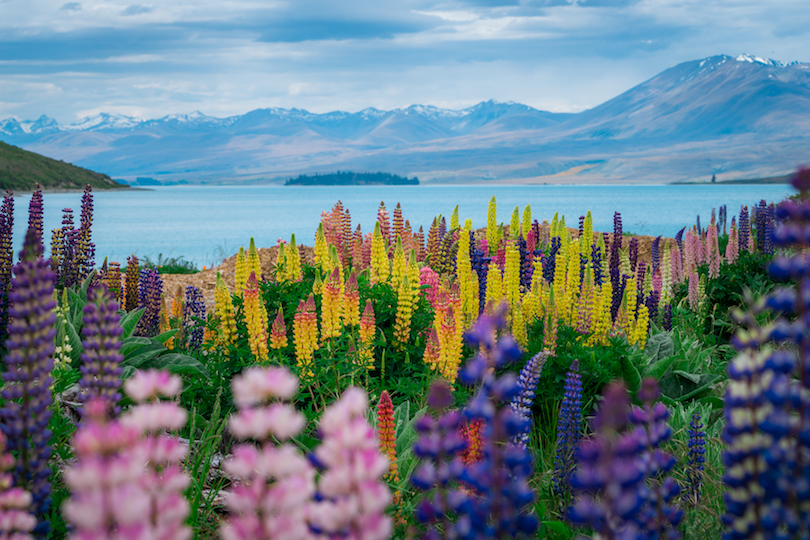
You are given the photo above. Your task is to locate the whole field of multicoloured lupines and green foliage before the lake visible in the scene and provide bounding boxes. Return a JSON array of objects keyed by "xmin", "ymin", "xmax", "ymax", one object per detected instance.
[{"xmin": 0, "ymin": 169, "xmax": 810, "ymax": 540}]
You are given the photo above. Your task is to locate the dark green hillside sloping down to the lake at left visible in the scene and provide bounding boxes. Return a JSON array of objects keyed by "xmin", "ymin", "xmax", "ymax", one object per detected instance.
[{"xmin": 0, "ymin": 142, "xmax": 129, "ymax": 191}]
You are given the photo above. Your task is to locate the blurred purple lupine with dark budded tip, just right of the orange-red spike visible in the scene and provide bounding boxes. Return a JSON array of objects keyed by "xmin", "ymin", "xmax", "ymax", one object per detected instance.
[{"xmin": 411, "ymin": 379, "xmax": 471, "ymax": 539}]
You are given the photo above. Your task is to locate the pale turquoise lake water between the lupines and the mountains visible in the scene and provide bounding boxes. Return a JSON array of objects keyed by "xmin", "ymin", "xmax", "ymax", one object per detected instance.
[{"xmin": 6, "ymin": 184, "xmax": 793, "ymax": 267}]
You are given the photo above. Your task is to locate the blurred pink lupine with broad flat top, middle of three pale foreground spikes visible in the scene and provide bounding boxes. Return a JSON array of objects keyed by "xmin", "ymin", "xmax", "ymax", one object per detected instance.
[{"xmin": 220, "ymin": 367, "xmax": 315, "ymax": 540}]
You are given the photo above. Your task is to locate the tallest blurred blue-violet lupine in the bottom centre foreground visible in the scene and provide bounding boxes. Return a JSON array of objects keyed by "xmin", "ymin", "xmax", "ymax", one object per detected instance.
[{"xmin": 459, "ymin": 305, "xmax": 539, "ymax": 538}]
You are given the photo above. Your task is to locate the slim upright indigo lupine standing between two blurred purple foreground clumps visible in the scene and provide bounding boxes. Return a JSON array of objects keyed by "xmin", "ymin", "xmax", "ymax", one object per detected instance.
[{"xmin": 552, "ymin": 359, "xmax": 582, "ymax": 506}]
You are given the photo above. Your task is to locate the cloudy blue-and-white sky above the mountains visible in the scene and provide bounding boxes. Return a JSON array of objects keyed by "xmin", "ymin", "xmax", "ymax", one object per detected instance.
[{"xmin": 0, "ymin": 0, "xmax": 810, "ymax": 124}]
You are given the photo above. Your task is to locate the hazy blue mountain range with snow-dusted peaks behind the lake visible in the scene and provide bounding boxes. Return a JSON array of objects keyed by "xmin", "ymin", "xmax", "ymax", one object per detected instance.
[{"xmin": 0, "ymin": 55, "xmax": 810, "ymax": 183}]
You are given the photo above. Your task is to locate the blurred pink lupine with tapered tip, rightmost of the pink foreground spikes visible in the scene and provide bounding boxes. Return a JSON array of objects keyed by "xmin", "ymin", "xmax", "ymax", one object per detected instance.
[{"xmin": 310, "ymin": 387, "xmax": 392, "ymax": 540}]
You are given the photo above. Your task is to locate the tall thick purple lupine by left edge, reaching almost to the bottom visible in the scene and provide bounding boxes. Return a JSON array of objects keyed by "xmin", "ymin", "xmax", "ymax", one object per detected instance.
[{"xmin": 0, "ymin": 229, "xmax": 56, "ymax": 538}]
